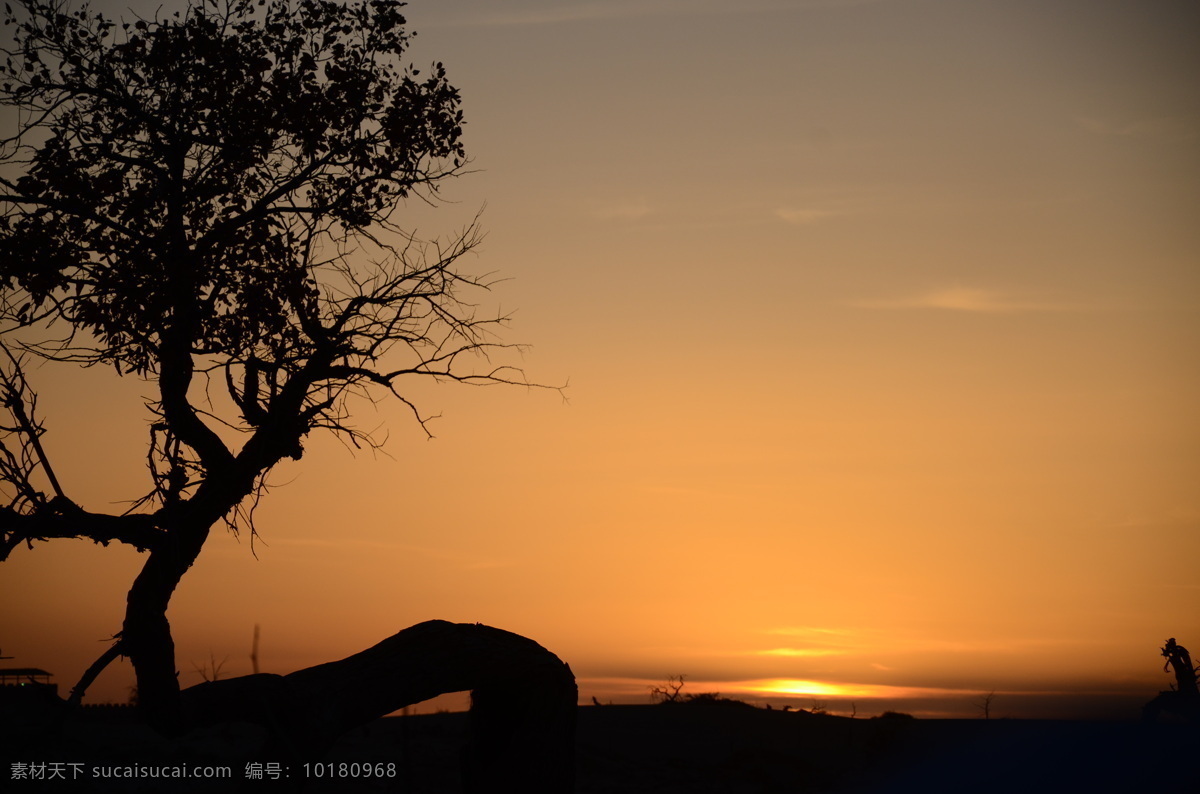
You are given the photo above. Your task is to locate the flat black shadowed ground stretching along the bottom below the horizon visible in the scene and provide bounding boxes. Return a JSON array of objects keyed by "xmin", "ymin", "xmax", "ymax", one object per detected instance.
[{"xmin": 0, "ymin": 703, "xmax": 1200, "ymax": 794}]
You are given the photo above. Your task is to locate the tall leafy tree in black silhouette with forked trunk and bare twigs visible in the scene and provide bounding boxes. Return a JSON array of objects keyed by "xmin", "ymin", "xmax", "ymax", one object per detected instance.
[{"xmin": 0, "ymin": 0, "xmax": 576, "ymax": 782}]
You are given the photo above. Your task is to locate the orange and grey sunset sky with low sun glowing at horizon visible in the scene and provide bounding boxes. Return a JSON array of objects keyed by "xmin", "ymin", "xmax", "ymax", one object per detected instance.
[{"xmin": 0, "ymin": 0, "xmax": 1200, "ymax": 716}]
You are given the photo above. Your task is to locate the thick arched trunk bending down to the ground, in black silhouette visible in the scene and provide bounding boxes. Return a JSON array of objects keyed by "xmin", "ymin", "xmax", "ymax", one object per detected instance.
[{"xmin": 182, "ymin": 620, "xmax": 578, "ymax": 794}]
